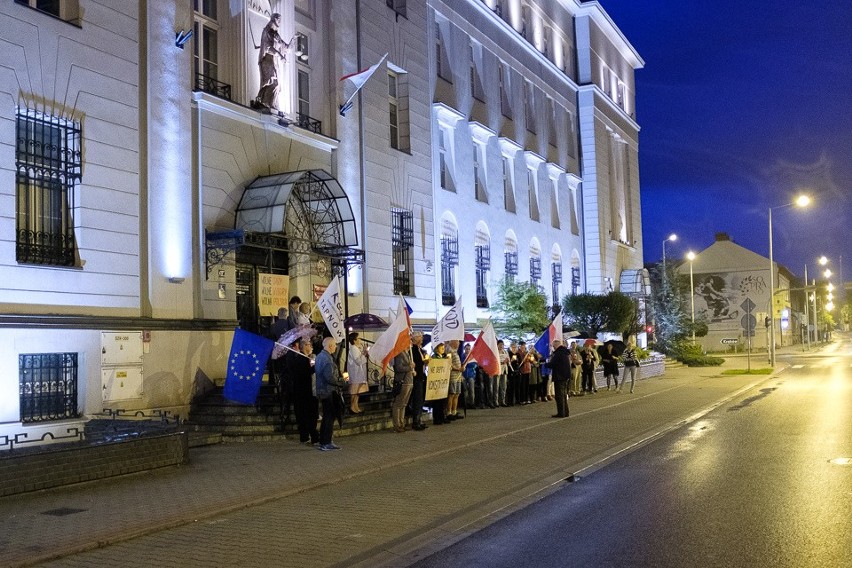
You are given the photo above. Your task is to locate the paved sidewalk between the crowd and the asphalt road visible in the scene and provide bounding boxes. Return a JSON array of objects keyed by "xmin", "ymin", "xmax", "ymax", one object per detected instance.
[{"xmin": 0, "ymin": 359, "xmax": 792, "ymax": 567}]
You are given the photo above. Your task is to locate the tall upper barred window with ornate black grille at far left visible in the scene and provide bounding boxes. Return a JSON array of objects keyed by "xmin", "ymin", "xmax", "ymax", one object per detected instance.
[{"xmin": 15, "ymin": 108, "xmax": 82, "ymax": 266}]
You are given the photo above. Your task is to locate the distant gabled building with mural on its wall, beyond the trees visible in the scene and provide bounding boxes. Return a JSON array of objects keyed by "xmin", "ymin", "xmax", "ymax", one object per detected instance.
[{"xmin": 677, "ymin": 233, "xmax": 806, "ymax": 351}]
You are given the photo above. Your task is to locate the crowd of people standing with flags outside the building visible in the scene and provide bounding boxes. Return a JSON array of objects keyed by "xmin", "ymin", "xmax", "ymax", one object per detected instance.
[{"xmin": 273, "ymin": 297, "xmax": 639, "ymax": 451}]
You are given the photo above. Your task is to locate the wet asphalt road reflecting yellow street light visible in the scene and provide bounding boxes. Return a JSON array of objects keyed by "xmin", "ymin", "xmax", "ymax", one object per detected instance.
[{"xmin": 415, "ymin": 340, "xmax": 852, "ymax": 568}]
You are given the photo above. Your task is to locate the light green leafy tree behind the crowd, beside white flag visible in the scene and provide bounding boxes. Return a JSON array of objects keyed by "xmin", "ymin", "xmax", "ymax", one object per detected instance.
[{"xmin": 491, "ymin": 278, "xmax": 550, "ymax": 338}]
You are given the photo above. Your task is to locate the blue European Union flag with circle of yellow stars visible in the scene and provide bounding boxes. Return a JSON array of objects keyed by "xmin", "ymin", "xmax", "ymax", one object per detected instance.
[{"xmin": 224, "ymin": 328, "xmax": 274, "ymax": 404}]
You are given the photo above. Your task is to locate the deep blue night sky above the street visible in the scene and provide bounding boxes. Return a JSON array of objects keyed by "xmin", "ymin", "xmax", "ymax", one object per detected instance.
[{"xmin": 599, "ymin": 0, "xmax": 852, "ymax": 280}]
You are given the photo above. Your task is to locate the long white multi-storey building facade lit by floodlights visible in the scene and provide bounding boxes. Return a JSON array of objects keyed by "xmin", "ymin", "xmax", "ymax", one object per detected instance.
[{"xmin": 0, "ymin": 0, "xmax": 642, "ymax": 450}]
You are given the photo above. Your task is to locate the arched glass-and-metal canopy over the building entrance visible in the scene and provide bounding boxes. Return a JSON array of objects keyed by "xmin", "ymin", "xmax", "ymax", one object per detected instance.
[{"xmin": 234, "ymin": 166, "xmax": 358, "ymax": 251}]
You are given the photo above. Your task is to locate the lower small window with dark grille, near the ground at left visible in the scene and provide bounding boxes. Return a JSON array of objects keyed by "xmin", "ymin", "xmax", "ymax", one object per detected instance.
[{"xmin": 18, "ymin": 353, "xmax": 79, "ymax": 423}]
